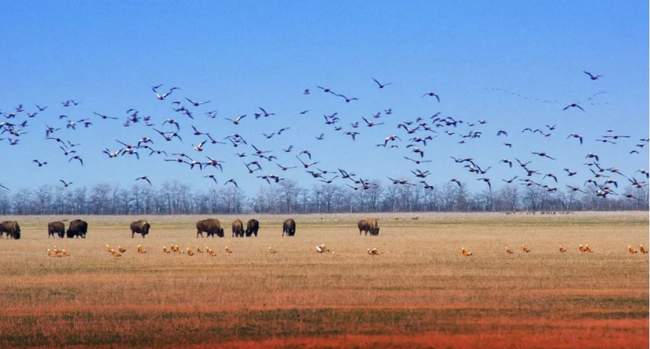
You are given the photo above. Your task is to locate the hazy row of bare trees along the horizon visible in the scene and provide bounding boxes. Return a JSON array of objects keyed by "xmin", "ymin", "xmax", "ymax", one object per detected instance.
[{"xmin": 0, "ymin": 180, "xmax": 648, "ymax": 215}]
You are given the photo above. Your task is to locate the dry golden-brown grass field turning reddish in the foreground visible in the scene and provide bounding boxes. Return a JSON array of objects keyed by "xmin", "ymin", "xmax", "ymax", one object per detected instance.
[{"xmin": 0, "ymin": 213, "xmax": 648, "ymax": 348}]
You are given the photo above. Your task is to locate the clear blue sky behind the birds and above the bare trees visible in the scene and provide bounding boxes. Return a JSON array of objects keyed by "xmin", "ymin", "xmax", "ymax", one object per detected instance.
[{"xmin": 0, "ymin": 1, "xmax": 648, "ymax": 194}]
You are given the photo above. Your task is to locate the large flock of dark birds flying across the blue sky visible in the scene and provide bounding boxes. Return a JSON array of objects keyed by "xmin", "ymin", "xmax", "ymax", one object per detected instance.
[{"xmin": 0, "ymin": 71, "xmax": 650, "ymax": 199}]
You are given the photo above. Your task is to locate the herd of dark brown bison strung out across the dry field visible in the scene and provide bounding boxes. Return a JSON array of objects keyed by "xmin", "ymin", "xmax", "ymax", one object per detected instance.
[{"xmin": 0, "ymin": 218, "xmax": 379, "ymax": 239}]
